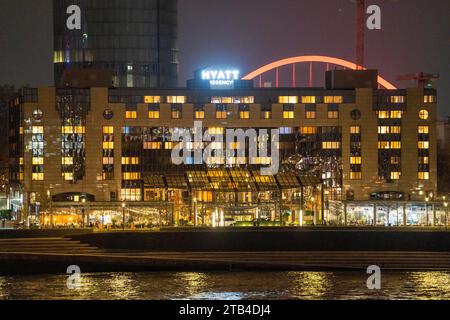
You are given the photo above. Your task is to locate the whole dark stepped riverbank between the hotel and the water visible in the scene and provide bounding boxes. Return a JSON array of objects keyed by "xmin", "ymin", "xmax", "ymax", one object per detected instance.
[{"xmin": 0, "ymin": 228, "xmax": 450, "ymax": 274}]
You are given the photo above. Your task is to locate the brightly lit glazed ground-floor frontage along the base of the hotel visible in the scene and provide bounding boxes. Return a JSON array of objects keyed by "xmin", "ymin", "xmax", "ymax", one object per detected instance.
[{"xmin": 16, "ymin": 197, "xmax": 449, "ymax": 230}]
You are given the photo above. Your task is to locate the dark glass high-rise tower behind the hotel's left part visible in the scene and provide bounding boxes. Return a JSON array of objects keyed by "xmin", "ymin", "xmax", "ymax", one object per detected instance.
[{"xmin": 53, "ymin": 0, "xmax": 178, "ymax": 88}]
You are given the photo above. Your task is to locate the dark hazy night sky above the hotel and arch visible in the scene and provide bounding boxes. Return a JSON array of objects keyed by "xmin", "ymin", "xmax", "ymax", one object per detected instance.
[{"xmin": 0, "ymin": 0, "xmax": 450, "ymax": 117}]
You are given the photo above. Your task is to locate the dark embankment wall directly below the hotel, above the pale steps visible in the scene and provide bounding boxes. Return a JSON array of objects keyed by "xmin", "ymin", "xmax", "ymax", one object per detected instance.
[{"xmin": 70, "ymin": 227, "xmax": 450, "ymax": 252}]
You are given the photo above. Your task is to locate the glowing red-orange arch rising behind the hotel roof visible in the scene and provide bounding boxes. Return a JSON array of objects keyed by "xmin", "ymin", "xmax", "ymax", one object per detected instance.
[{"xmin": 242, "ymin": 56, "xmax": 397, "ymax": 90}]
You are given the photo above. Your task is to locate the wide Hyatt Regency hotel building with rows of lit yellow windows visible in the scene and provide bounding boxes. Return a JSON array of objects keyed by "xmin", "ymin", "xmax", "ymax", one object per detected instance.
[{"xmin": 10, "ymin": 70, "xmax": 447, "ymax": 228}]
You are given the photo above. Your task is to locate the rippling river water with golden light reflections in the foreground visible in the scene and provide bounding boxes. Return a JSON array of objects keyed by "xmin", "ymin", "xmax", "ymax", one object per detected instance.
[{"xmin": 0, "ymin": 271, "xmax": 450, "ymax": 300}]
